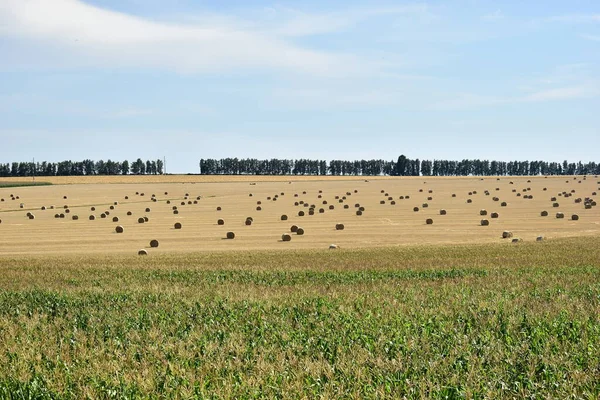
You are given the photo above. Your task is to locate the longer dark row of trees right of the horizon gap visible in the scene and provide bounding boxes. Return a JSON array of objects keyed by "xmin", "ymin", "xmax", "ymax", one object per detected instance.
[{"xmin": 200, "ymin": 155, "xmax": 600, "ymax": 176}]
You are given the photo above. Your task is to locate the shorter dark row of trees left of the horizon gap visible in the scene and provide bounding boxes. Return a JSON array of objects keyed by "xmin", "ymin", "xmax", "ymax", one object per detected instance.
[{"xmin": 0, "ymin": 158, "xmax": 164, "ymax": 177}]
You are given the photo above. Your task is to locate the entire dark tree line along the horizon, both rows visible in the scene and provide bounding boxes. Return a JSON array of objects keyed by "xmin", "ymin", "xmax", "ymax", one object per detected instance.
[{"xmin": 0, "ymin": 155, "xmax": 600, "ymax": 177}]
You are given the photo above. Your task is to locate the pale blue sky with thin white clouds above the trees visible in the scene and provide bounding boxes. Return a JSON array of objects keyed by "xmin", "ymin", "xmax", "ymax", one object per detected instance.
[{"xmin": 0, "ymin": 0, "xmax": 600, "ymax": 173}]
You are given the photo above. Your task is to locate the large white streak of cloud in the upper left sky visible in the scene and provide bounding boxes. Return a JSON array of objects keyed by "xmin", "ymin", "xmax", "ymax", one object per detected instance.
[{"xmin": 0, "ymin": 0, "xmax": 358, "ymax": 75}]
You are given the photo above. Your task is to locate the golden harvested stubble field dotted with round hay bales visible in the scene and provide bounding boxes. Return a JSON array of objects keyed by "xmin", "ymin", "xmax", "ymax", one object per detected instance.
[{"xmin": 0, "ymin": 176, "xmax": 600, "ymax": 254}]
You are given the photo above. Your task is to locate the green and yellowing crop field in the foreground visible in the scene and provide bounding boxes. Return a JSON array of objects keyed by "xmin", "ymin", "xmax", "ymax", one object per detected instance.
[{"xmin": 0, "ymin": 237, "xmax": 600, "ymax": 399}]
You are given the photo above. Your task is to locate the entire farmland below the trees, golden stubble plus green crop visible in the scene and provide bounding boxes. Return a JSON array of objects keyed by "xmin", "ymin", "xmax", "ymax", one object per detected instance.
[{"xmin": 0, "ymin": 176, "xmax": 600, "ymax": 399}]
